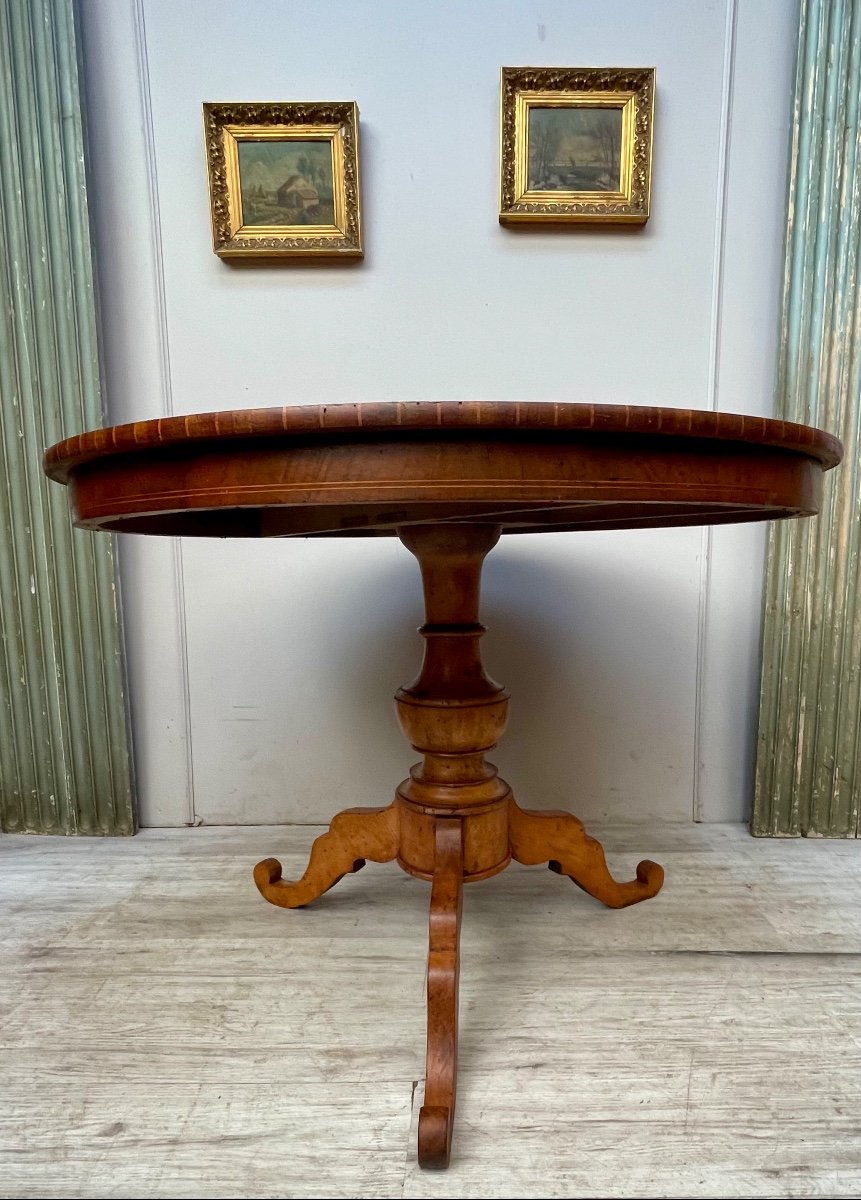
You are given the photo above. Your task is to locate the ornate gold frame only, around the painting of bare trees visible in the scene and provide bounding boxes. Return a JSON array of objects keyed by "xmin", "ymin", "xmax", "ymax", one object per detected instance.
[{"xmin": 499, "ymin": 67, "xmax": 655, "ymax": 224}]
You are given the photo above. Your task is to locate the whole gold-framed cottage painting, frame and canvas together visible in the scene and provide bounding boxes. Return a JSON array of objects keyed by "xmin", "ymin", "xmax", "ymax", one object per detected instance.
[{"xmin": 204, "ymin": 101, "xmax": 363, "ymax": 259}]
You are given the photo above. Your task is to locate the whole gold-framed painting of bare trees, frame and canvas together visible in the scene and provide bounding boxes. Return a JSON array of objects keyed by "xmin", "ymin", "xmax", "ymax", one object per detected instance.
[{"xmin": 499, "ymin": 67, "xmax": 655, "ymax": 224}]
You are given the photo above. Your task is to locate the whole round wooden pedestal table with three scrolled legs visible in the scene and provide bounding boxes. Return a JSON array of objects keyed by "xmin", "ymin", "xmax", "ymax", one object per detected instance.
[{"xmin": 46, "ymin": 402, "xmax": 842, "ymax": 1166}]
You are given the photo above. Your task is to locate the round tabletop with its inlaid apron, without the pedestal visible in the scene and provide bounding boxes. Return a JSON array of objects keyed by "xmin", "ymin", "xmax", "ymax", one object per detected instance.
[{"xmin": 44, "ymin": 401, "xmax": 842, "ymax": 536}]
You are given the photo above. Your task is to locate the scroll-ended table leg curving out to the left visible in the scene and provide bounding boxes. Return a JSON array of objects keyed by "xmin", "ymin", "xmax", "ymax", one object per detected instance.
[{"xmin": 254, "ymin": 804, "xmax": 399, "ymax": 908}]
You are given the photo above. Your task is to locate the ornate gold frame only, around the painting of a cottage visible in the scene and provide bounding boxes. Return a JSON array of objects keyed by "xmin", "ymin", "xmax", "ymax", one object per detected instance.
[{"xmin": 204, "ymin": 101, "xmax": 363, "ymax": 258}]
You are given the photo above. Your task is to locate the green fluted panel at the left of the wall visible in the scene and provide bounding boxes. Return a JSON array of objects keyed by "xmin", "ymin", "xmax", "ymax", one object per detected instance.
[{"xmin": 0, "ymin": 0, "xmax": 134, "ymax": 834}]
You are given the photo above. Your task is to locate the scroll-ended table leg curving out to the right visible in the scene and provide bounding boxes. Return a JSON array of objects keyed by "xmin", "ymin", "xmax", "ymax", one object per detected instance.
[{"xmin": 508, "ymin": 800, "xmax": 663, "ymax": 908}]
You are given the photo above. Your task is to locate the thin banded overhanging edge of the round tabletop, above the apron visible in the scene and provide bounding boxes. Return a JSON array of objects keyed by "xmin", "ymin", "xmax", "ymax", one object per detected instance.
[{"xmin": 44, "ymin": 401, "xmax": 843, "ymax": 484}]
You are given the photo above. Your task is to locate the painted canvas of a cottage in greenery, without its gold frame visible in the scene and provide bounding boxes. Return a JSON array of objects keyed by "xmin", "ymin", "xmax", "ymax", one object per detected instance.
[{"xmin": 239, "ymin": 139, "xmax": 335, "ymax": 226}]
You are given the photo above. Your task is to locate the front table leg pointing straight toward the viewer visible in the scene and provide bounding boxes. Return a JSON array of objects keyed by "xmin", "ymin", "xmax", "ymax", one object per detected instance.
[{"xmin": 419, "ymin": 817, "xmax": 463, "ymax": 1170}]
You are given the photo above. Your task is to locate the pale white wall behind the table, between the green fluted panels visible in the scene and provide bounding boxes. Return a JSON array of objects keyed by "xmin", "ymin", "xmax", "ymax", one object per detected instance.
[{"xmin": 80, "ymin": 0, "xmax": 797, "ymax": 824}]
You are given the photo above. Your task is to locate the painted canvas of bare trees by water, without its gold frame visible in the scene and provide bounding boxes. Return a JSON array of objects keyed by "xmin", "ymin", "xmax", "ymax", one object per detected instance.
[{"xmin": 526, "ymin": 104, "xmax": 622, "ymax": 192}]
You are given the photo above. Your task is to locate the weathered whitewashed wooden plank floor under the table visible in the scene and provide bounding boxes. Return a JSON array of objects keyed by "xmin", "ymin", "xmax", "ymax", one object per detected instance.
[{"xmin": 0, "ymin": 826, "xmax": 861, "ymax": 1198}]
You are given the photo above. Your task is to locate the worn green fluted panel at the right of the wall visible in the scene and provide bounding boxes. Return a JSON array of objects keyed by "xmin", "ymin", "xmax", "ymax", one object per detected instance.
[{"xmin": 752, "ymin": 0, "xmax": 861, "ymax": 838}]
